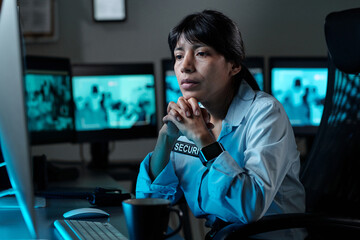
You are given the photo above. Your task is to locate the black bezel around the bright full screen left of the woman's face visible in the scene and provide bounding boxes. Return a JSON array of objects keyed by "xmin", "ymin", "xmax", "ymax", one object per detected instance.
[{"xmin": 72, "ymin": 63, "xmax": 158, "ymax": 143}]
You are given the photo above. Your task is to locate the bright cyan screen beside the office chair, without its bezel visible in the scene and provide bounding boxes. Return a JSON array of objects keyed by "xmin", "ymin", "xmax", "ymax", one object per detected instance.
[{"xmin": 271, "ymin": 68, "xmax": 328, "ymax": 126}]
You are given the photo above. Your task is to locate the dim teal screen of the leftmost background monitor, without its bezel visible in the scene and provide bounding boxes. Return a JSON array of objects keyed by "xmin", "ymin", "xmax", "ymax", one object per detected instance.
[{"xmin": 25, "ymin": 71, "xmax": 74, "ymax": 132}]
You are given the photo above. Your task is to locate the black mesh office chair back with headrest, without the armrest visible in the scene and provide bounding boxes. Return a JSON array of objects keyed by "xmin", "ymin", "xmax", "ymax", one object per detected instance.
[{"xmin": 301, "ymin": 8, "xmax": 360, "ymax": 217}]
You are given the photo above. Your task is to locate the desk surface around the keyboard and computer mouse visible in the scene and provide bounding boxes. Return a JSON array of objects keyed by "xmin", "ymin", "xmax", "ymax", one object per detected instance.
[{"xmin": 0, "ymin": 169, "xmax": 181, "ymax": 239}]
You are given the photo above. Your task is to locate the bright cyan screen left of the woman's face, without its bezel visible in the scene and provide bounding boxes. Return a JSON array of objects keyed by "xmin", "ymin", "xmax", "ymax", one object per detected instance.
[{"xmin": 73, "ymin": 74, "xmax": 156, "ymax": 131}]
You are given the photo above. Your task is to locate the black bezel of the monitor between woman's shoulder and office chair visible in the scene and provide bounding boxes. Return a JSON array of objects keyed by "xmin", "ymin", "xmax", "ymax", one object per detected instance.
[{"xmin": 268, "ymin": 56, "xmax": 328, "ymax": 136}]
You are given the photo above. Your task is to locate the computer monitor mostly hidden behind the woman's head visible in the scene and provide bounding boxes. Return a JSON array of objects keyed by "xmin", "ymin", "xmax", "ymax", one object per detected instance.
[{"xmin": 161, "ymin": 57, "xmax": 265, "ymax": 114}]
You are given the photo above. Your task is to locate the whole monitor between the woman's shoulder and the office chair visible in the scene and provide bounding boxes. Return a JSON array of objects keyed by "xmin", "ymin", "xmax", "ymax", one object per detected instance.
[{"xmin": 269, "ymin": 57, "xmax": 328, "ymax": 135}]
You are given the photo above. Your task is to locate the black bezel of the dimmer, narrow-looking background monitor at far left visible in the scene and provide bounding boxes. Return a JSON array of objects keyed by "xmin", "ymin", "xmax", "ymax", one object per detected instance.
[{"xmin": 25, "ymin": 55, "xmax": 76, "ymax": 145}]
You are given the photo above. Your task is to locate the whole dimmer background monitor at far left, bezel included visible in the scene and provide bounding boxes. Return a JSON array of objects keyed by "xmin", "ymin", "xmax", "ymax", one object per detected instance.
[{"xmin": 25, "ymin": 56, "xmax": 75, "ymax": 145}]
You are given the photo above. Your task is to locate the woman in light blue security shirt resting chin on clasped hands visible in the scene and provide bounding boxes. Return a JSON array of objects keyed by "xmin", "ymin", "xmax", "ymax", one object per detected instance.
[{"xmin": 136, "ymin": 10, "xmax": 305, "ymax": 240}]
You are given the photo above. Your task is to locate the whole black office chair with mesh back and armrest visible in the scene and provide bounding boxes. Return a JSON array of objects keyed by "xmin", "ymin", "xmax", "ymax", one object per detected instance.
[{"xmin": 214, "ymin": 8, "xmax": 360, "ymax": 240}]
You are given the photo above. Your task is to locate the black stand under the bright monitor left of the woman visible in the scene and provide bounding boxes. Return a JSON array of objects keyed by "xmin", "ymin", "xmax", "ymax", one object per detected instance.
[{"xmin": 88, "ymin": 142, "xmax": 109, "ymax": 169}]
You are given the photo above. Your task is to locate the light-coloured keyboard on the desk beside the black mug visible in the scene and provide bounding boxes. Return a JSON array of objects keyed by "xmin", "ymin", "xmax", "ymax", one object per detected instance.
[{"xmin": 54, "ymin": 220, "xmax": 128, "ymax": 240}]
